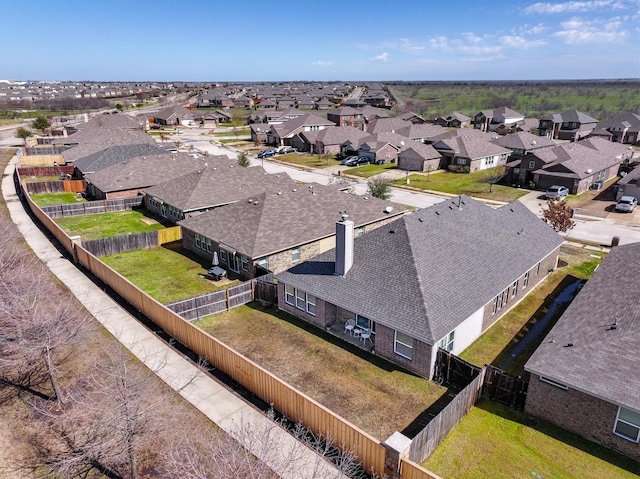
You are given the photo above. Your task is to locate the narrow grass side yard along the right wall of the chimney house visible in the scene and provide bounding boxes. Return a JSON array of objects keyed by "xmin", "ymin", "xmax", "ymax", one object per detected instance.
[{"xmin": 460, "ymin": 246, "xmax": 606, "ymax": 375}]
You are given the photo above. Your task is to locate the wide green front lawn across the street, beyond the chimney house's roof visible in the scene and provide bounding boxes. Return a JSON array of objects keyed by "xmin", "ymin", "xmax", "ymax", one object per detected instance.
[{"xmin": 394, "ymin": 171, "xmax": 529, "ymax": 202}]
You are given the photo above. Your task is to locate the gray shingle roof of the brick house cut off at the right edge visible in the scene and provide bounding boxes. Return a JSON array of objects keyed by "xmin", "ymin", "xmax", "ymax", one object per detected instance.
[{"xmin": 525, "ymin": 243, "xmax": 640, "ymax": 411}]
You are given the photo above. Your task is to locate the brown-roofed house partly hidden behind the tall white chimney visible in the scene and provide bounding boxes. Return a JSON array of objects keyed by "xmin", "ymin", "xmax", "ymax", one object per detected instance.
[{"xmin": 178, "ymin": 181, "xmax": 405, "ymax": 279}]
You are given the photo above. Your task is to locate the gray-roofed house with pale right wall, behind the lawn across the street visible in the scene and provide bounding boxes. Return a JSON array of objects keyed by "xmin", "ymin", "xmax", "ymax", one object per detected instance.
[{"xmin": 433, "ymin": 135, "xmax": 510, "ymax": 172}]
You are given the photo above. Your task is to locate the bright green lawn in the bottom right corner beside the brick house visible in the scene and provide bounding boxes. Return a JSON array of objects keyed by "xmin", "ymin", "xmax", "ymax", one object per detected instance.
[{"xmin": 422, "ymin": 401, "xmax": 640, "ymax": 479}]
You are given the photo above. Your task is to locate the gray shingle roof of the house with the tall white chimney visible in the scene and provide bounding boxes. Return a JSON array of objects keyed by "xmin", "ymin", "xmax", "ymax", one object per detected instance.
[{"xmin": 277, "ymin": 196, "xmax": 562, "ymax": 344}]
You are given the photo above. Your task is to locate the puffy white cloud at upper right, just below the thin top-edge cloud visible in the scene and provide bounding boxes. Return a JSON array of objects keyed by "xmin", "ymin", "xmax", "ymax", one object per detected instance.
[{"xmin": 552, "ymin": 18, "xmax": 629, "ymax": 45}]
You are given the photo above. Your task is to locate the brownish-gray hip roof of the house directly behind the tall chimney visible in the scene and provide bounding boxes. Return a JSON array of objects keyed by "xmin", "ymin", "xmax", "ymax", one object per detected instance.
[{"xmin": 179, "ymin": 186, "xmax": 404, "ymax": 258}]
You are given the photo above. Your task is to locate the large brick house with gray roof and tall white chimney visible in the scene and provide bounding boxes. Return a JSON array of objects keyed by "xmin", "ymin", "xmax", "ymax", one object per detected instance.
[{"xmin": 276, "ymin": 196, "xmax": 562, "ymax": 378}]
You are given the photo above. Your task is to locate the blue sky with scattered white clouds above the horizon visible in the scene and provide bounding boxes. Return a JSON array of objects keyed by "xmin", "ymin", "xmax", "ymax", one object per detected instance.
[{"xmin": 0, "ymin": 0, "xmax": 640, "ymax": 81}]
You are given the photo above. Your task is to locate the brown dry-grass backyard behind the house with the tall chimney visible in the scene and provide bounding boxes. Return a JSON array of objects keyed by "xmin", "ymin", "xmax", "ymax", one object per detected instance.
[{"xmin": 195, "ymin": 306, "xmax": 446, "ymax": 440}]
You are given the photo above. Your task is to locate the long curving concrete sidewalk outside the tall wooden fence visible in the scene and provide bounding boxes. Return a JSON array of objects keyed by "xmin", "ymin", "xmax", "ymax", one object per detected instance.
[{"xmin": 2, "ymin": 157, "xmax": 345, "ymax": 479}]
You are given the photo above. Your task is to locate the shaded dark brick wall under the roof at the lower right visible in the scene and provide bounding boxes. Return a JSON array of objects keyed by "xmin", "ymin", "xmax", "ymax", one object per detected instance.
[{"xmin": 525, "ymin": 376, "xmax": 640, "ymax": 459}]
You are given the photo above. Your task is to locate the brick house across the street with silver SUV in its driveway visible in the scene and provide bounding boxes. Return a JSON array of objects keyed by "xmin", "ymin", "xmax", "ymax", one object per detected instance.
[{"xmin": 518, "ymin": 138, "xmax": 633, "ymax": 195}]
